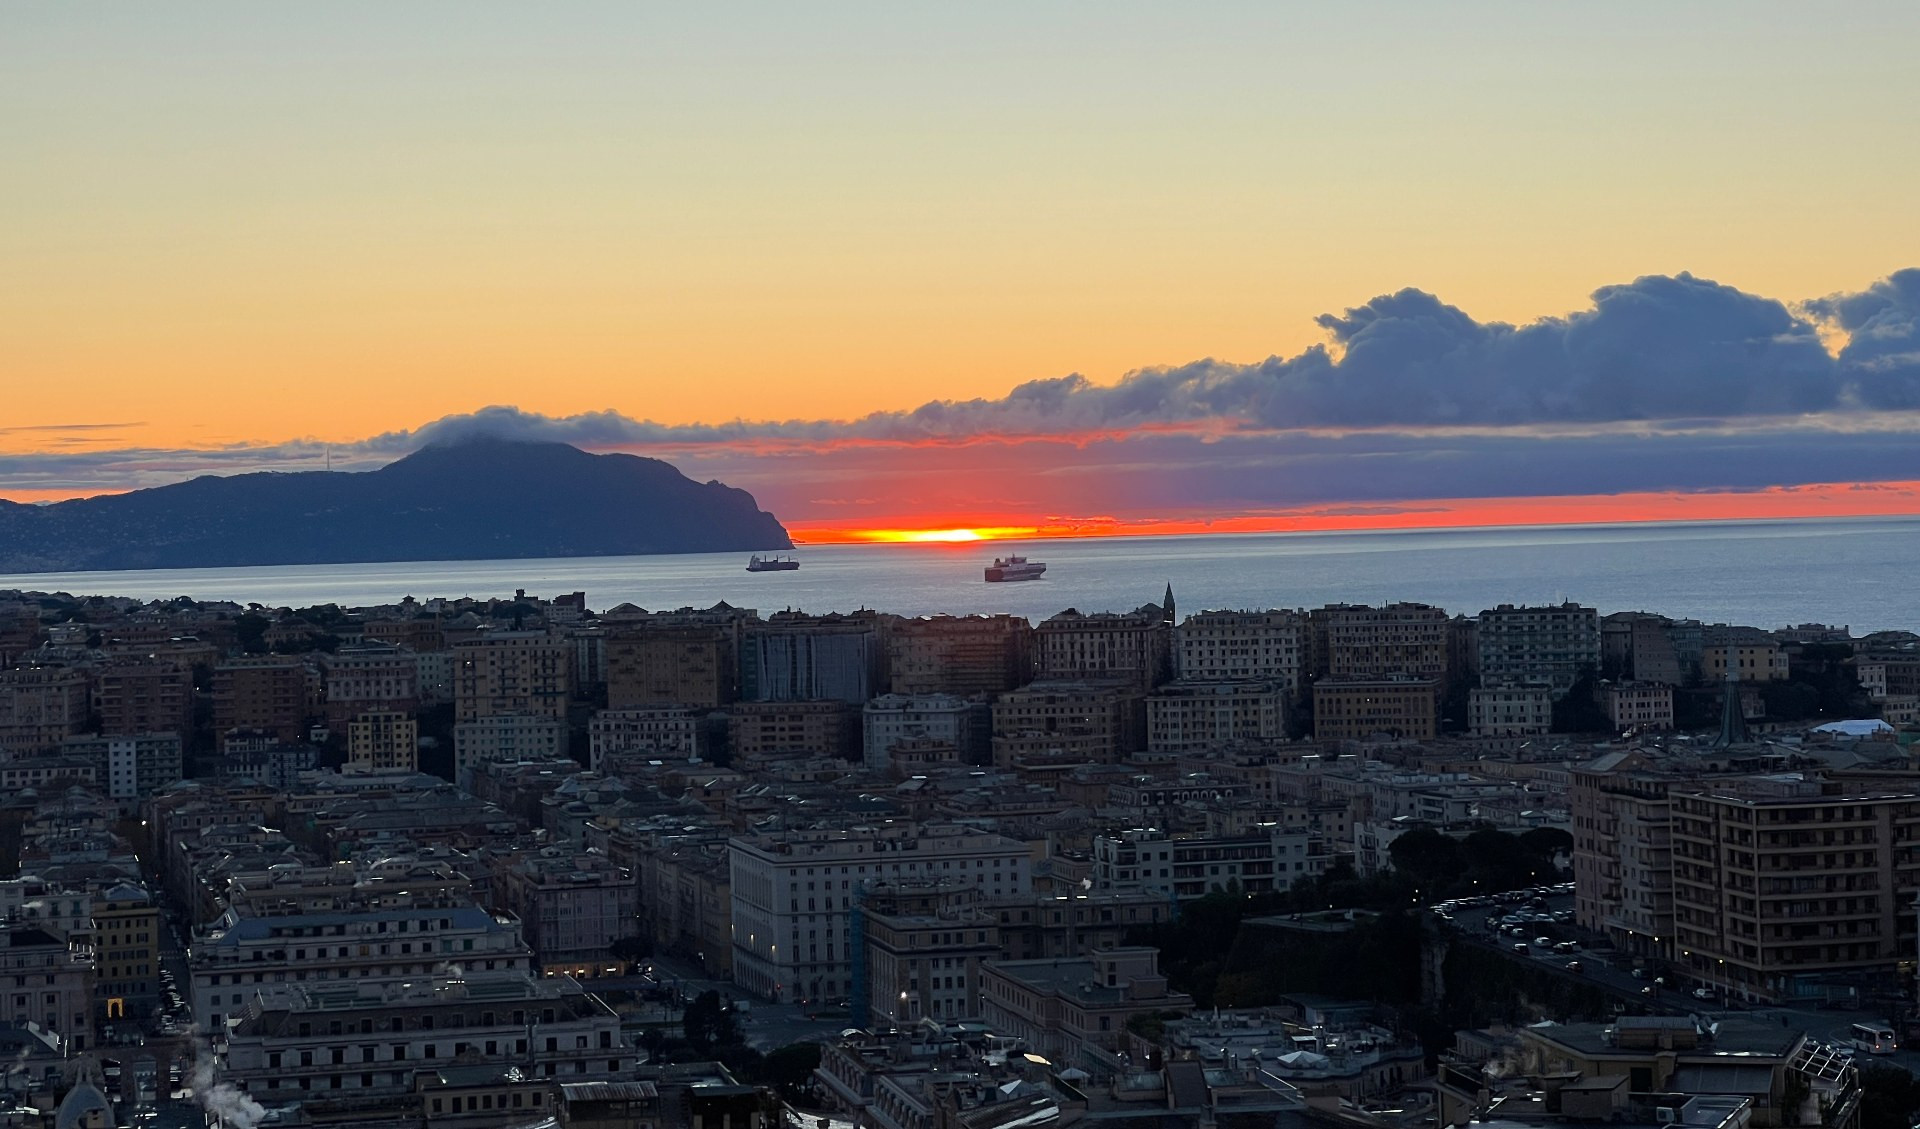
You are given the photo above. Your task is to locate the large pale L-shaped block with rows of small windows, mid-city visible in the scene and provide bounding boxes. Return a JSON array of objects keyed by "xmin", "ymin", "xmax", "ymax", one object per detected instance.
[{"xmin": 728, "ymin": 824, "xmax": 1033, "ymax": 1000}]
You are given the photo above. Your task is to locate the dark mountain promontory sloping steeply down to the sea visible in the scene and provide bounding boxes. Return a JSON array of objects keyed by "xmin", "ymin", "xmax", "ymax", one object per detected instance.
[{"xmin": 0, "ymin": 438, "xmax": 793, "ymax": 572}]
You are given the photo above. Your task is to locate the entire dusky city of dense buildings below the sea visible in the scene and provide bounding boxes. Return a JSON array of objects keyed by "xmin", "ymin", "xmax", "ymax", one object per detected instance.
[{"xmin": 0, "ymin": 584, "xmax": 1920, "ymax": 1129}]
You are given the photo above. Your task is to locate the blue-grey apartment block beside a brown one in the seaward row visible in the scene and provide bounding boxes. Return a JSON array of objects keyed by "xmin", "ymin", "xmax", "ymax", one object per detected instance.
[{"xmin": 739, "ymin": 613, "xmax": 887, "ymax": 707}]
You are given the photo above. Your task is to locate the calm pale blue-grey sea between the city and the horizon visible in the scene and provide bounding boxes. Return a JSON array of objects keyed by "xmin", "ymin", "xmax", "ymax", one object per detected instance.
[{"xmin": 0, "ymin": 518, "xmax": 1920, "ymax": 634}]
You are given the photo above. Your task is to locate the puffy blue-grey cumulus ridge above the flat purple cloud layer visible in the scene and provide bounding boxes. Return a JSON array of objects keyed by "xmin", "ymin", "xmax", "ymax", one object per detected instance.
[{"xmin": 349, "ymin": 271, "xmax": 1889, "ymax": 449}]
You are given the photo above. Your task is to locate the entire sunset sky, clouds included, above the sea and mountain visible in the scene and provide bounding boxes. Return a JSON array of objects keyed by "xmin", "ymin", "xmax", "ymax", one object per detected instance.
[{"xmin": 0, "ymin": 0, "xmax": 1920, "ymax": 538}]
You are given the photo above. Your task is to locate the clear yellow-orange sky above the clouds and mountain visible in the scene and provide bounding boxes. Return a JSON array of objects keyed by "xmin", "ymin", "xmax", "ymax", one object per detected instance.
[{"xmin": 0, "ymin": 0, "xmax": 1920, "ymax": 451}]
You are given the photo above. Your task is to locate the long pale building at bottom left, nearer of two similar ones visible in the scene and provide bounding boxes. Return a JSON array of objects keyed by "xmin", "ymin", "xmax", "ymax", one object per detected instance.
[{"xmin": 217, "ymin": 973, "xmax": 637, "ymax": 1104}]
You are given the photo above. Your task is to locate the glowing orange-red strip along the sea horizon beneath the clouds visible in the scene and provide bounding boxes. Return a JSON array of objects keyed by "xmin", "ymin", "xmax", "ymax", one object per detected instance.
[{"xmin": 785, "ymin": 482, "xmax": 1920, "ymax": 545}]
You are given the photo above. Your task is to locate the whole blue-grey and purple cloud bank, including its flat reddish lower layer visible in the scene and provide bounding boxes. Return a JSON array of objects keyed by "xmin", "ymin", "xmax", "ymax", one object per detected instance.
[{"xmin": 0, "ymin": 269, "xmax": 1920, "ymax": 516}]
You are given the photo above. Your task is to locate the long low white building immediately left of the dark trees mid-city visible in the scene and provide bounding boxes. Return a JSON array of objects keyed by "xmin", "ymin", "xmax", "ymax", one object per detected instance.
[{"xmin": 1092, "ymin": 824, "xmax": 1332, "ymax": 899}]
